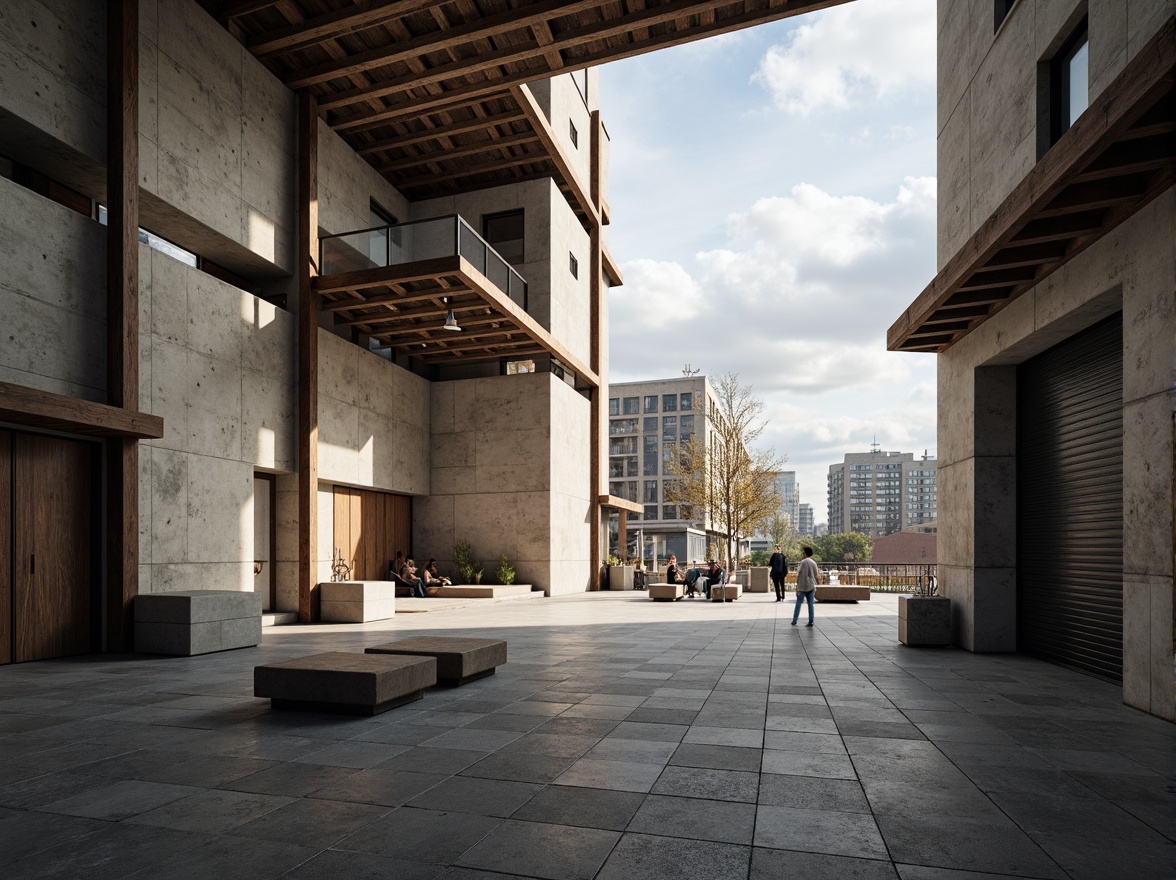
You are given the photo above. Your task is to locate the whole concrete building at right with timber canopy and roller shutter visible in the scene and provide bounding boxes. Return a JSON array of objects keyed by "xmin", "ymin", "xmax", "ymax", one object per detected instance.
[{"xmin": 888, "ymin": 0, "xmax": 1176, "ymax": 719}]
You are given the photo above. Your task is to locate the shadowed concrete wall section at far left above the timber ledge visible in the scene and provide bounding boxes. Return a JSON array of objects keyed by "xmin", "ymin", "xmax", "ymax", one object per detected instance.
[{"xmin": 0, "ymin": 178, "xmax": 106, "ymax": 402}]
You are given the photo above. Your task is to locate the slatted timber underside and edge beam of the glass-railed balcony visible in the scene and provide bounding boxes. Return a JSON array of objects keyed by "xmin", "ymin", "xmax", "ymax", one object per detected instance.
[{"xmin": 313, "ymin": 255, "xmax": 600, "ymax": 388}]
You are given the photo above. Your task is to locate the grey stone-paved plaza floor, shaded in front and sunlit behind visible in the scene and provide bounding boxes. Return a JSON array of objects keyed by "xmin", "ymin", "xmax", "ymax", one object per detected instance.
[{"xmin": 0, "ymin": 593, "xmax": 1176, "ymax": 880}]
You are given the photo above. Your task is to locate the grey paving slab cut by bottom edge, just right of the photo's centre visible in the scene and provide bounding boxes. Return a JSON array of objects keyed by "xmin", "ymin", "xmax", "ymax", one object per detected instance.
[{"xmin": 596, "ymin": 833, "xmax": 751, "ymax": 880}]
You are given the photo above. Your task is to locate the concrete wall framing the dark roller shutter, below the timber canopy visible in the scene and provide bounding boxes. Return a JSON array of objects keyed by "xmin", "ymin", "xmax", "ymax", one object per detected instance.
[{"xmin": 938, "ymin": 188, "xmax": 1176, "ymax": 719}]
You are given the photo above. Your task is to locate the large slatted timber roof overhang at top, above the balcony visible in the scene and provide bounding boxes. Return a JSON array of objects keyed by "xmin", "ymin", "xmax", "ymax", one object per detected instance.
[{"xmin": 211, "ymin": 0, "xmax": 847, "ymax": 204}]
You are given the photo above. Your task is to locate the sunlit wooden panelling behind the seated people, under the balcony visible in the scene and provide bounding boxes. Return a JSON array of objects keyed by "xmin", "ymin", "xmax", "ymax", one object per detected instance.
[{"xmin": 334, "ymin": 486, "xmax": 413, "ymax": 580}]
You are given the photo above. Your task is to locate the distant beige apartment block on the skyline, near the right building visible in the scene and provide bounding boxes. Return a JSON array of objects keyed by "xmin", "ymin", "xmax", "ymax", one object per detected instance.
[{"xmin": 828, "ymin": 451, "xmax": 937, "ymax": 538}]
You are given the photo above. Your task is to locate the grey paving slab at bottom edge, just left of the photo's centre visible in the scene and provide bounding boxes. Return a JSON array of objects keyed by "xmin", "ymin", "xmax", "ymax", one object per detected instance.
[{"xmin": 459, "ymin": 819, "xmax": 621, "ymax": 880}]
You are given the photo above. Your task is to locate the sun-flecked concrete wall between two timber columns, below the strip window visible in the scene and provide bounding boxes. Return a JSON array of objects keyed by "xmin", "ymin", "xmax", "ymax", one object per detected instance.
[{"xmin": 139, "ymin": 245, "xmax": 296, "ymax": 594}]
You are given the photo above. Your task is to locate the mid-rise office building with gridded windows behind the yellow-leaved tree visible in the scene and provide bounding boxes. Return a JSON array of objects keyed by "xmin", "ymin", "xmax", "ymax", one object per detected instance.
[{"xmin": 608, "ymin": 375, "xmax": 719, "ymax": 559}]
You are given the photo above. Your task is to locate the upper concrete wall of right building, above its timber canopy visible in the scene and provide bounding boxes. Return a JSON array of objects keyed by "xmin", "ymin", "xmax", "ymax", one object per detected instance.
[{"xmin": 938, "ymin": 0, "xmax": 1176, "ymax": 268}]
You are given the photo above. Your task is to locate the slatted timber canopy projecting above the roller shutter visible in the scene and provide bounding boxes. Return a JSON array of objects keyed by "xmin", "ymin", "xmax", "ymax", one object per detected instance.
[{"xmin": 887, "ymin": 18, "xmax": 1176, "ymax": 352}]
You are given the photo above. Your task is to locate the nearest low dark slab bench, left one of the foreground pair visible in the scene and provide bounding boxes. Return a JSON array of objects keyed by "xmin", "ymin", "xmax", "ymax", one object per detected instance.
[{"xmin": 253, "ymin": 651, "xmax": 437, "ymax": 715}]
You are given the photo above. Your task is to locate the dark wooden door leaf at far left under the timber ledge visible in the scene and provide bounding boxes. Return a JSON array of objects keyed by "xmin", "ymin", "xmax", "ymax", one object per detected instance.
[{"xmin": 12, "ymin": 434, "xmax": 94, "ymax": 661}]
